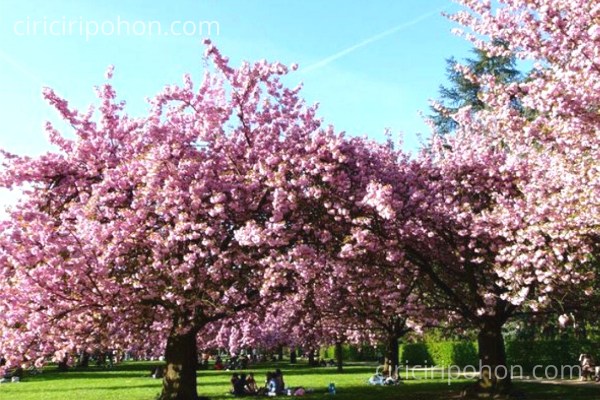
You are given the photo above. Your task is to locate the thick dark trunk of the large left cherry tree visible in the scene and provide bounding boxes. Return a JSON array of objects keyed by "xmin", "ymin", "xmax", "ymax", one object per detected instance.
[{"xmin": 159, "ymin": 331, "xmax": 198, "ymax": 400}]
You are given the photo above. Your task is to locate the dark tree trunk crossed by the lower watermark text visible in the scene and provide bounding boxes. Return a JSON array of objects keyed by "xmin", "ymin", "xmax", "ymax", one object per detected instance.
[{"xmin": 477, "ymin": 321, "xmax": 511, "ymax": 395}]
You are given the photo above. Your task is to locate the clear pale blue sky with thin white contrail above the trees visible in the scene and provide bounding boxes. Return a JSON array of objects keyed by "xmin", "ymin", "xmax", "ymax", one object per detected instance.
[{"xmin": 0, "ymin": 0, "xmax": 470, "ymax": 212}]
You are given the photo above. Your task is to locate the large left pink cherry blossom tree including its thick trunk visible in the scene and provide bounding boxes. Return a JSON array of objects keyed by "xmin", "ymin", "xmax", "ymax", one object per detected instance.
[{"xmin": 0, "ymin": 42, "xmax": 392, "ymax": 400}]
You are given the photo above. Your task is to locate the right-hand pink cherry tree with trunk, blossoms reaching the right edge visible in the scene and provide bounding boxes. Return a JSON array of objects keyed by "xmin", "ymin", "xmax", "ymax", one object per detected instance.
[{"xmin": 386, "ymin": 0, "xmax": 600, "ymax": 390}]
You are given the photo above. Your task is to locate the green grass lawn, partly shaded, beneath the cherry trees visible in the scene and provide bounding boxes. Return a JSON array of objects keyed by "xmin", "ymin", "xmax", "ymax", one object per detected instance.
[{"xmin": 0, "ymin": 362, "xmax": 600, "ymax": 400}]
